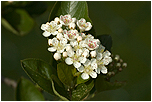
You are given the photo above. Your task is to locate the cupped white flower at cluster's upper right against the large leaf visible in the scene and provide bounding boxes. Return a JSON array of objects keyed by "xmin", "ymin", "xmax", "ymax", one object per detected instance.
[{"xmin": 77, "ymin": 18, "xmax": 92, "ymax": 31}]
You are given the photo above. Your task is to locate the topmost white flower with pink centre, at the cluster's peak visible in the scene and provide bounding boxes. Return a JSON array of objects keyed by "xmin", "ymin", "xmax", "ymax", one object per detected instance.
[{"xmin": 60, "ymin": 15, "xmax": 76, "ymax": 26}]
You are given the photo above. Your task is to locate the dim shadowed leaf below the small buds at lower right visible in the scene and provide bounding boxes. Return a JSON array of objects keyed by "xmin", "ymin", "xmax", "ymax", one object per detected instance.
[{"xmin": 95, "ymin": 76, "xmax": 126, "ymax": 92}]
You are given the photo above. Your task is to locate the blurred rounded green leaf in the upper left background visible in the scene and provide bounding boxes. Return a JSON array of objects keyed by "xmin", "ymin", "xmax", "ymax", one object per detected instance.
[{"xmin": 2, "ymin": 8, "xmax": 34, "ymax": 36}]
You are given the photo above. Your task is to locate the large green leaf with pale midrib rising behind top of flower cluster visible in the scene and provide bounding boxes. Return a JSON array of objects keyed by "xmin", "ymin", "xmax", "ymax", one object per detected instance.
[{"xmin": 48, "ymin": 1, "xmax": 95, "ymax": 36}]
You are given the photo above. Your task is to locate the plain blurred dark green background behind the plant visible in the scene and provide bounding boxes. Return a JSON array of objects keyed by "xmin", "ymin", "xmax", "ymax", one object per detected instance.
[{"xmin": 1, "ymin": 1, "xmax": 151, "ymax": 101}]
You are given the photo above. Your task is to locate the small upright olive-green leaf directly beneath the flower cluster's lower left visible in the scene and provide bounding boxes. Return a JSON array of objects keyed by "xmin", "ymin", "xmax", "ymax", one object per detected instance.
[{"xmin": 57, "ymin": 63, "xmax": 74, "ymax": 87}]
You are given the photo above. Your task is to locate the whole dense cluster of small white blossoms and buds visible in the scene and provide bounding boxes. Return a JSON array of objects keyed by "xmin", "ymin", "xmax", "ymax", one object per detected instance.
[{"xmin": 41, "ymin": 15, "xmax": 112, "ymax": 79}]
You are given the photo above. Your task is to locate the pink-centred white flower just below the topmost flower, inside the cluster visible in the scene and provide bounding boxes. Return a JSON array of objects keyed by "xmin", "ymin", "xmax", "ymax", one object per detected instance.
[{"xmin": 63, "ymin": 30, "xmax": 79, "ymax": 40}]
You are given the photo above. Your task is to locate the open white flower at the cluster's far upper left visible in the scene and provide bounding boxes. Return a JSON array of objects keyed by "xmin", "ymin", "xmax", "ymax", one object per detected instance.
[{"xmin": 41, "ymin": 21, "xmax": 62, "ymax": 37}]
